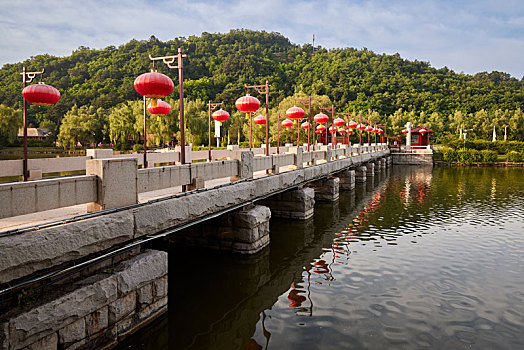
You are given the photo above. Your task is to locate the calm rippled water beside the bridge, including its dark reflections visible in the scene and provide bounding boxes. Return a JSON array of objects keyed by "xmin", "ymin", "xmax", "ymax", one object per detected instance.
[{"xmin": 121, "ymin": 167, "xmax": 524, "ymax": 349}]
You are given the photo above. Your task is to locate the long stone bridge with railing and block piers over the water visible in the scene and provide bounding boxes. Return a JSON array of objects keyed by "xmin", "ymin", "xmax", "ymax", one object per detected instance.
[{"xmin": 0, "ymin": 144, "xmax": 391, "ymax": 349}]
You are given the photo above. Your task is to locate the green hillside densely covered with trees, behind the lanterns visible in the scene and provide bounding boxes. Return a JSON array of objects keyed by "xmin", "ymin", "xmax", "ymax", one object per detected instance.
[{"xmin": 0, "ymin": 30, "xmax": 524, "ymax": 144}]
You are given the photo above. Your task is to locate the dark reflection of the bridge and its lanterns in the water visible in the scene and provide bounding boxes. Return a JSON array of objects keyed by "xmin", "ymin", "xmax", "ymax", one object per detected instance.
[{"xmin": 162, "ymin": 168, "xmax": 400, "ymax": 349}]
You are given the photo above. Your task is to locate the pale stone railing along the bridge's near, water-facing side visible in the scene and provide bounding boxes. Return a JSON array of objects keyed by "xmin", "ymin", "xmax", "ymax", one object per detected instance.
[{"xmin": 0, "ymin": 144, "xmax": 387, "ymax": 219}]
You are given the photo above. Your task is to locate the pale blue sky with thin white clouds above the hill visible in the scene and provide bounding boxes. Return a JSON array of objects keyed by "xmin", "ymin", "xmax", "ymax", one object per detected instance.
[{"xmin": 0, "ymin": 0, "xmax": 524, "ymax": 79}]
